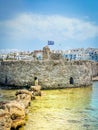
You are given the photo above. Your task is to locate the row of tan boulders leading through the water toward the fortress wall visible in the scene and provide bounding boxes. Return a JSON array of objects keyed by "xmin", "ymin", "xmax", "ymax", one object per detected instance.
[{"xmin": 0, "ymin": 85, "xmax": 41, "ymax": 130}]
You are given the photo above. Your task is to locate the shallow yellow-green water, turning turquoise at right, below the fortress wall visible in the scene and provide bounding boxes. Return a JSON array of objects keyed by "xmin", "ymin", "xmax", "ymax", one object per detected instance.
[{"xmin": 0, "ymin": 82, "xmax": 98, "ymax": 130}]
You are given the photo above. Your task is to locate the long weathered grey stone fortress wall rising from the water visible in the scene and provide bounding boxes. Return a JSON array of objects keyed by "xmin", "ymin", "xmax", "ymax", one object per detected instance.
[{"xmin": 0, "ymin": 59, "xmax": 98, "ymax": 89}]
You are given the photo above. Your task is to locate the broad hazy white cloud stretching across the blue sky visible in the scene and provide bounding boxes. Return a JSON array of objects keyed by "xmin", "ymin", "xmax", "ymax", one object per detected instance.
[{"xmin": 0, "ymin": 14, "xmax": 98, "ymax": 42}]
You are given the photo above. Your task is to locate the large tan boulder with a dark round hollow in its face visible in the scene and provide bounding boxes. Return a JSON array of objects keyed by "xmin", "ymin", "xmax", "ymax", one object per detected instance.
[{"xmin": 4, "ymin": 101, "xmax": 25, "ymax": 129}]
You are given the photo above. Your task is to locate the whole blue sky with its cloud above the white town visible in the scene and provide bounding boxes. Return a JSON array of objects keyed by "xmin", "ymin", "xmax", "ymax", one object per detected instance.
[{"xmin": 0, "ymin": 0, "xmax": 98, "ymax": 51}]
